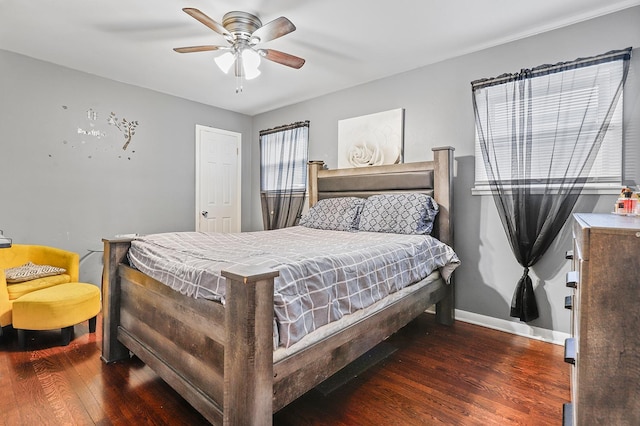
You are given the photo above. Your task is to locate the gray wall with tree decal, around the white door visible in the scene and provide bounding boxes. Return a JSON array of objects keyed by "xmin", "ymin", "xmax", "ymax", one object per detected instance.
[{"xmin": 0, "ymin": 50, "xmax": 253, "ymax": 284}]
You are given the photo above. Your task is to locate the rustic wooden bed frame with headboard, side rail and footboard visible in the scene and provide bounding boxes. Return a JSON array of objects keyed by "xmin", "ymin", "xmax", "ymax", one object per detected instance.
[{"xmin": 102, "ymin": 147, "xmax": 454, "ymax": 425}]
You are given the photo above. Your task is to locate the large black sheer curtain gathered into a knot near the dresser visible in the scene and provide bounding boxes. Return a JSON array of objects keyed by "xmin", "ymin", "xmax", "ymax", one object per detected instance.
[{"xmin": 471, "ymin": 48, "xmax": 631, "ymax": 321}]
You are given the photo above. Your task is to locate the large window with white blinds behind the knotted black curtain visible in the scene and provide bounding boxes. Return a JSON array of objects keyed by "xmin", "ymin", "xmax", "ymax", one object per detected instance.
[{"xmin": 472, "ymin": 50, "xmax": 624, "ymax": 194}]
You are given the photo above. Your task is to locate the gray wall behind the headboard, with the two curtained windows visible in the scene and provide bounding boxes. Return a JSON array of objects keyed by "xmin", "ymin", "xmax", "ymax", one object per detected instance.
[{"xmin": 252, "ymin": 7, "xmax": 640, "ymax": 333}]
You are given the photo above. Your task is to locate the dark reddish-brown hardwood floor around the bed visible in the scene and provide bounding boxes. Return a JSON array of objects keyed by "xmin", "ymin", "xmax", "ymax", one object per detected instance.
[{"xmin": 0, "ymin": 314, "xmax": 570, "ymax": 426}]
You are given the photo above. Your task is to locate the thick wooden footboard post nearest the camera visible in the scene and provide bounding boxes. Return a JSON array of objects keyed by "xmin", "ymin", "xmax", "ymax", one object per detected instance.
[{"xmin": 221, "ymin": 266, "xmax": 279, "ymax": 425}]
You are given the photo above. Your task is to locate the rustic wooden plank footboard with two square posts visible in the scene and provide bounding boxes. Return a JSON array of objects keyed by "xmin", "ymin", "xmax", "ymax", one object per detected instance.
[{"xmin": 102, "ymin": 240, "xmax": 278, "ymax": 425}]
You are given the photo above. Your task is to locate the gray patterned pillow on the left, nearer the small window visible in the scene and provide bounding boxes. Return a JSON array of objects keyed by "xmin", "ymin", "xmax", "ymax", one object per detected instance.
[{"xmin": 300, "ymin": 197, "xmax": 365, "ymax": 231}]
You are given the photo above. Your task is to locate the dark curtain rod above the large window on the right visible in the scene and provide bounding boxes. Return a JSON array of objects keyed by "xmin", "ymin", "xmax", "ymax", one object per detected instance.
[{"xmin": 471, "ymin": 47, "xmax": 633, "ymax": 90}]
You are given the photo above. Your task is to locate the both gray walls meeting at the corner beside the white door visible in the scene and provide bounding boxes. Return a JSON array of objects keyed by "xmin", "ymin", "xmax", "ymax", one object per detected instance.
[{"xmin": 0, "ymin": 7, "xmax": 640, "ymax": 332}]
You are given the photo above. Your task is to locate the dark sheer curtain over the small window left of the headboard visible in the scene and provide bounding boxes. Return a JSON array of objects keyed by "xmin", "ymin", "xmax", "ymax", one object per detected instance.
[{"xmin": 260, "ymin": 121, "xmax": 309, "ymax": 230}]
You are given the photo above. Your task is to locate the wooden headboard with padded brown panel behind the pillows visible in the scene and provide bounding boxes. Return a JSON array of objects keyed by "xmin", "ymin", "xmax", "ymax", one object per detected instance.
[{"xmin": 309, "ymin": 146, "xmax": 454, "ymax": 247}]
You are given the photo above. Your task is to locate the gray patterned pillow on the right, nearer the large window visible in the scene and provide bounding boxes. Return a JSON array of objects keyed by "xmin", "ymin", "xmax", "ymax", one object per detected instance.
[{"xmin": 360, "ymin": 193, "xmax": 438, "ymax": 235}]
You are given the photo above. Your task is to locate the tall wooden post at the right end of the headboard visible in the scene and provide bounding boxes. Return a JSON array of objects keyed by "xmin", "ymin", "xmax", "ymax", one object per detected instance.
[{"xmin": 432, "ymin": 146, "xmax": 455, "ymax": 325}]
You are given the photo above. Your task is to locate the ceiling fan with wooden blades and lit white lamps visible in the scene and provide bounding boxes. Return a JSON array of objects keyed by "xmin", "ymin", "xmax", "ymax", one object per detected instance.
[{"xmin": 173, "ymin": 7, "xmax": 305, "ymax": 92}]
